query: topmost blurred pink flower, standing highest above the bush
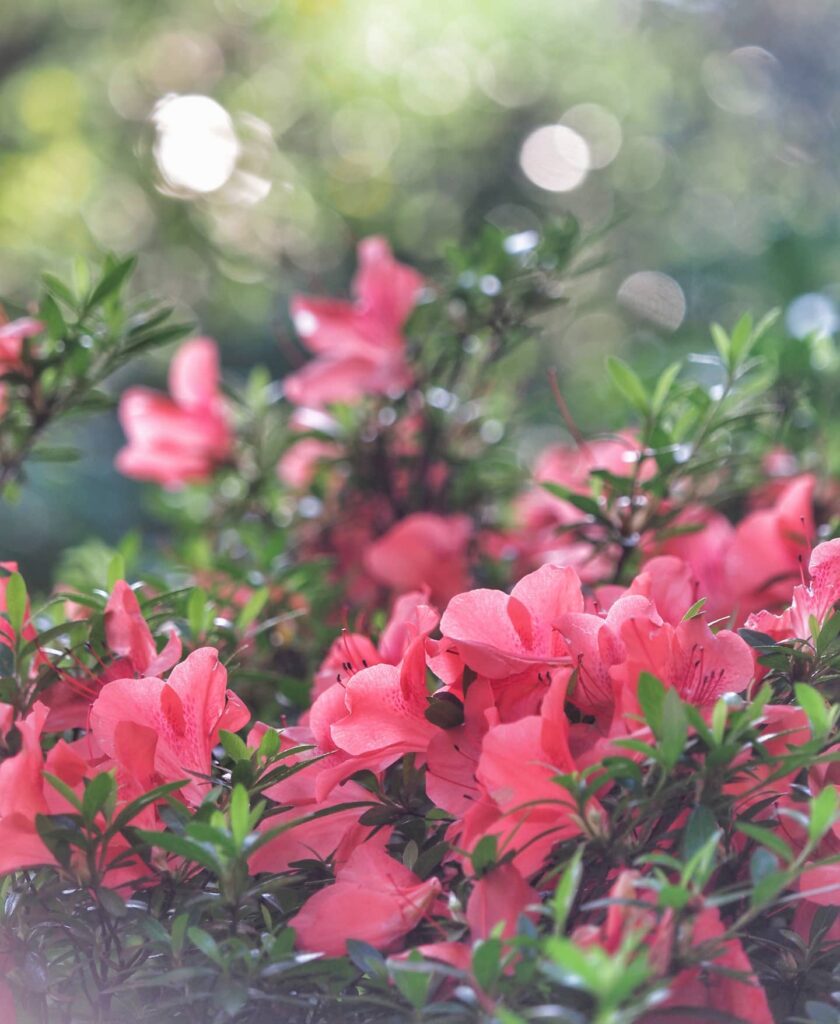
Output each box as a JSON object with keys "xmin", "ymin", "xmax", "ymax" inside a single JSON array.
[{"xmin": 284, "ymin": 238, "xmax": 423, "ymax": 408}]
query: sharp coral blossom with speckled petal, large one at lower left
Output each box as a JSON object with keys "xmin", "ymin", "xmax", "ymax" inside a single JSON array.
[{"xmin": 90, "ymin": 647, "xmax": 249, "ymax": 804}]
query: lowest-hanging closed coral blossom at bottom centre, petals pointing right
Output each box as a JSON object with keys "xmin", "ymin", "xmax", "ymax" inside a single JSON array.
[{"xmin": 290, "ymin": 839, "xmax": 440, "ymax": 956}]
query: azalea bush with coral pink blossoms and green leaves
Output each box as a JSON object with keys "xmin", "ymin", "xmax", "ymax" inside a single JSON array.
[{"xmin": 0, "ymin": 226, "xmax": 840, "ymax": 1024}]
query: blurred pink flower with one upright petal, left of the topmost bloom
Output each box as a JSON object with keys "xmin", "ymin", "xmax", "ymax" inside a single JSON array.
[{"xmin": 116, "ymin": 338, "xmax": 232, "ymax": 487}]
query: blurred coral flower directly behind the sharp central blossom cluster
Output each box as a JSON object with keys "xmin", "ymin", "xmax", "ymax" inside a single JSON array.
[{"xmin": 364, "ymin": 512, "xmax": 472, "ymax": 604}]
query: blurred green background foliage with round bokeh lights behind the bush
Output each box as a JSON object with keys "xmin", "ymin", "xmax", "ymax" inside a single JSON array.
[{"xmin": 0, "ymin": 0, "xmax": 840, "ymax": 581}]
